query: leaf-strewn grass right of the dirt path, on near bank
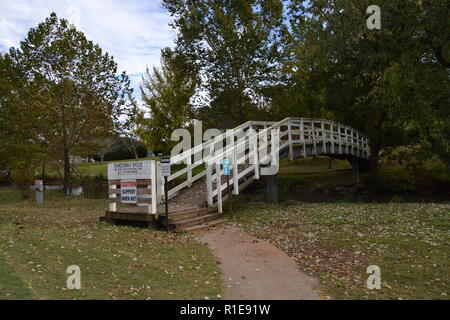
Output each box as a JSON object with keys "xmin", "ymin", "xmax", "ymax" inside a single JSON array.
[{"xmin": 230, "ymin": 202, "xmax": 450, "ymax": 299}]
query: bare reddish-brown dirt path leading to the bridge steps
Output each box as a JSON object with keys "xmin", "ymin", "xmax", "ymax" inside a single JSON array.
[{"xmin": 198, "ymin": 226, "xmax": 319, "ymax": 300}]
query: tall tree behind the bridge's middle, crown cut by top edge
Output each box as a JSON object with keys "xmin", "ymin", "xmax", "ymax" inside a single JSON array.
[{"xmin": 163, "ymin": 0, "xmax": 286, "ymax": 129}]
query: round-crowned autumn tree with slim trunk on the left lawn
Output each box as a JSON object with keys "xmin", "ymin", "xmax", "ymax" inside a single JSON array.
[{"xmin": 7, "ymin": 13, "xmax": 131, "ymax": 191}]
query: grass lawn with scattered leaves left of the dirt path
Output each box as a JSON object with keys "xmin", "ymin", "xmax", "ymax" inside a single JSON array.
[{"xmin": 0, "ymin": 191, "xmax": 224, "ymax": 299}]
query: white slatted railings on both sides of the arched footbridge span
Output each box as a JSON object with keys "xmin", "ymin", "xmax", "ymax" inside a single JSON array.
[{"xmin": 156, "ymin": 118, "xmax": 370, "ymax": 212}]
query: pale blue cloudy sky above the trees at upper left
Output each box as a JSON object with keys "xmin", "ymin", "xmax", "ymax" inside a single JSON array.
[{"xmin": 0, "ymin": 0, "xmax": 175, "ymax": 99}]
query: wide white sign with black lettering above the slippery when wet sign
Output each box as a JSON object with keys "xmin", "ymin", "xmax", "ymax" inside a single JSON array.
[{"xmin": 108, "ymin": 161, "xmax": 151, "ymax": 180}]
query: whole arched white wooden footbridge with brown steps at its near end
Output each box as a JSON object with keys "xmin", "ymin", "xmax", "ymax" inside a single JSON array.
[{"xmin": 104, "ymin": 118, "xmax": 370, "ymax": 231}]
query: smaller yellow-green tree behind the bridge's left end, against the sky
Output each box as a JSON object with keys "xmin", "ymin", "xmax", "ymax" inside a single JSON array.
[{"xmin": 136, "ymin": 49, "xmax": 197, "ymax": 154}]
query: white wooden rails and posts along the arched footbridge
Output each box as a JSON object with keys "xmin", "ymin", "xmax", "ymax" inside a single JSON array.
[{"xmin": 158, "ymin": 118, "xmax": 370, "ymax": 211}]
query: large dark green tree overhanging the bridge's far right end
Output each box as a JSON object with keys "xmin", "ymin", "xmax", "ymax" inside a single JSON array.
[{"xmin": 289, "ymin": 0, "xmax": 450, "ymax": 181}]
